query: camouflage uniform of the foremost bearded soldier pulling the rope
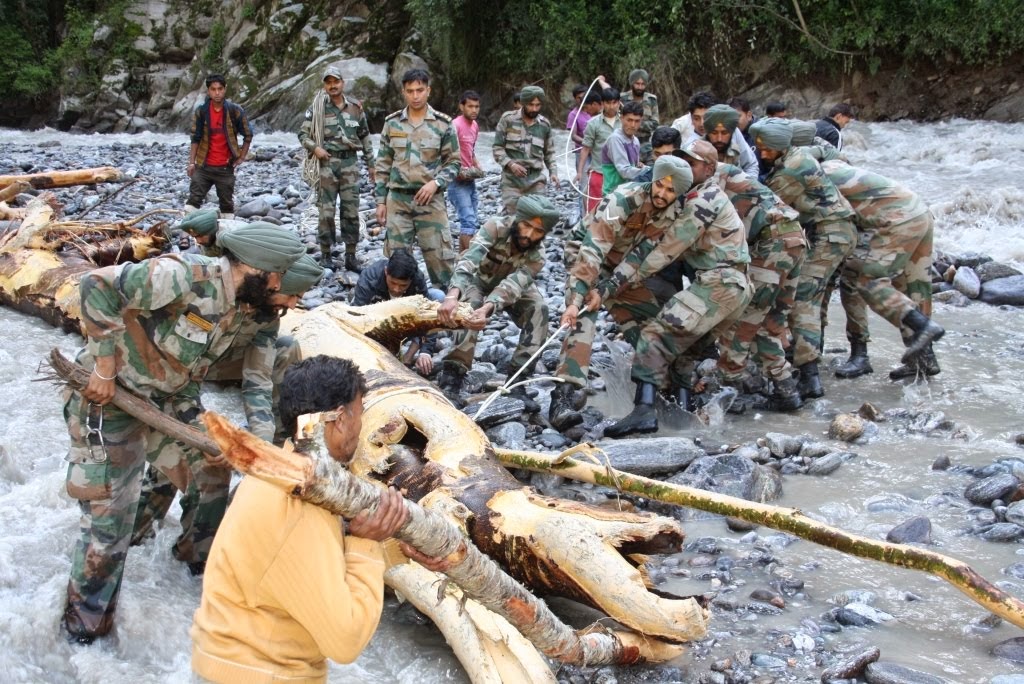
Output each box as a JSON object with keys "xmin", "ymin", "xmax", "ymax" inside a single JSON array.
[{"xmin": 555, "ymin": 183, "xmax": 682, "ymax": 387}]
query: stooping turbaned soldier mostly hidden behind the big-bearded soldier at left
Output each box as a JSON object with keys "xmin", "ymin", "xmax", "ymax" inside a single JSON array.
[{"xmin": 132, "ymin": 254, "xmax": 324, "ymax": 546}]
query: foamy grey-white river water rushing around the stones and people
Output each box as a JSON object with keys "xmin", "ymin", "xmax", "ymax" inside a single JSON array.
[{"xmin": 0, "ymin": 120, "xmax": 1024, "ymax": 684}]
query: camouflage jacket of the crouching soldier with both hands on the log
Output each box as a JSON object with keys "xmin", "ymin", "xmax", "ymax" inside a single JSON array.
[{"xmin": 451, "ymin": 216, "xmax": 544, "ymax": 311}]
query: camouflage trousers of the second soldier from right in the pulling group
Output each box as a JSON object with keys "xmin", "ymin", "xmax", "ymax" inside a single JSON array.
[{"xmin": 790, "ymin": 220, "xmax": 857, "ymax": 367}]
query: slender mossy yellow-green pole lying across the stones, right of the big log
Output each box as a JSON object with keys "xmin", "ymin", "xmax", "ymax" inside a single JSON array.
[{"xmin": 495, "ymin": 445, "xmax": 1024, "ymax": 628}]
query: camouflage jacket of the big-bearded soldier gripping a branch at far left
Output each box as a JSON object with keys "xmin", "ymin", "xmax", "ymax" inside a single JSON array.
[{"xmin": 80, "ymin": 254, "xmax": 246, "ymax": 398}]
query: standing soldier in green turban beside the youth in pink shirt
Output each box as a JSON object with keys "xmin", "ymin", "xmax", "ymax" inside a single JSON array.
[{"xmin": 492, "ymin": 86, "xmax": 558, "ymax": 216}]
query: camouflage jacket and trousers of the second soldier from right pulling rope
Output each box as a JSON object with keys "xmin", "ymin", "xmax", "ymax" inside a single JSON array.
[{"xmin": 766, "ymin": 146, "xmax": 857, "ymax": 366}]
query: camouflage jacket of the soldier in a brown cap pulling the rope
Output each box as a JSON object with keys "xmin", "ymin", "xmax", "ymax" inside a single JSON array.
[{"xmin": 611, "ymin": 176, "xmax": 751, "ymax": 287}]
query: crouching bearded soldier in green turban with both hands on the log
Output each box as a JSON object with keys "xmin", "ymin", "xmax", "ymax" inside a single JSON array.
[{"xmin": 437, "ymin": 195, "xmax": 560, "ymax": 403}]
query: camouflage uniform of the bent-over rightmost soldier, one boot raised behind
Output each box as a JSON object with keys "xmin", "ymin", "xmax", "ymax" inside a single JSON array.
[{"xmin": 821, "ymin": 161, "xmax": 933, "ymax": 341}]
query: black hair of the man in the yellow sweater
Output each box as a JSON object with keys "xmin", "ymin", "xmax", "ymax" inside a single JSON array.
[{"xmin": 279, "ymin": 354, "xmax": 367, "ymax": 435}]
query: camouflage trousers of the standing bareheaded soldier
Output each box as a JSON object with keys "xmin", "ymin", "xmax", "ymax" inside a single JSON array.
[{"xmin": 384, "ymin": 190, "xmax": 455, "ymax": 290}]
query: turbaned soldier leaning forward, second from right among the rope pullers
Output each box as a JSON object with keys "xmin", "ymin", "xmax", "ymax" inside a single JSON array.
[{"xmin": 751, "ymin": 119, "xmax": 857, "ymax": 399}]
